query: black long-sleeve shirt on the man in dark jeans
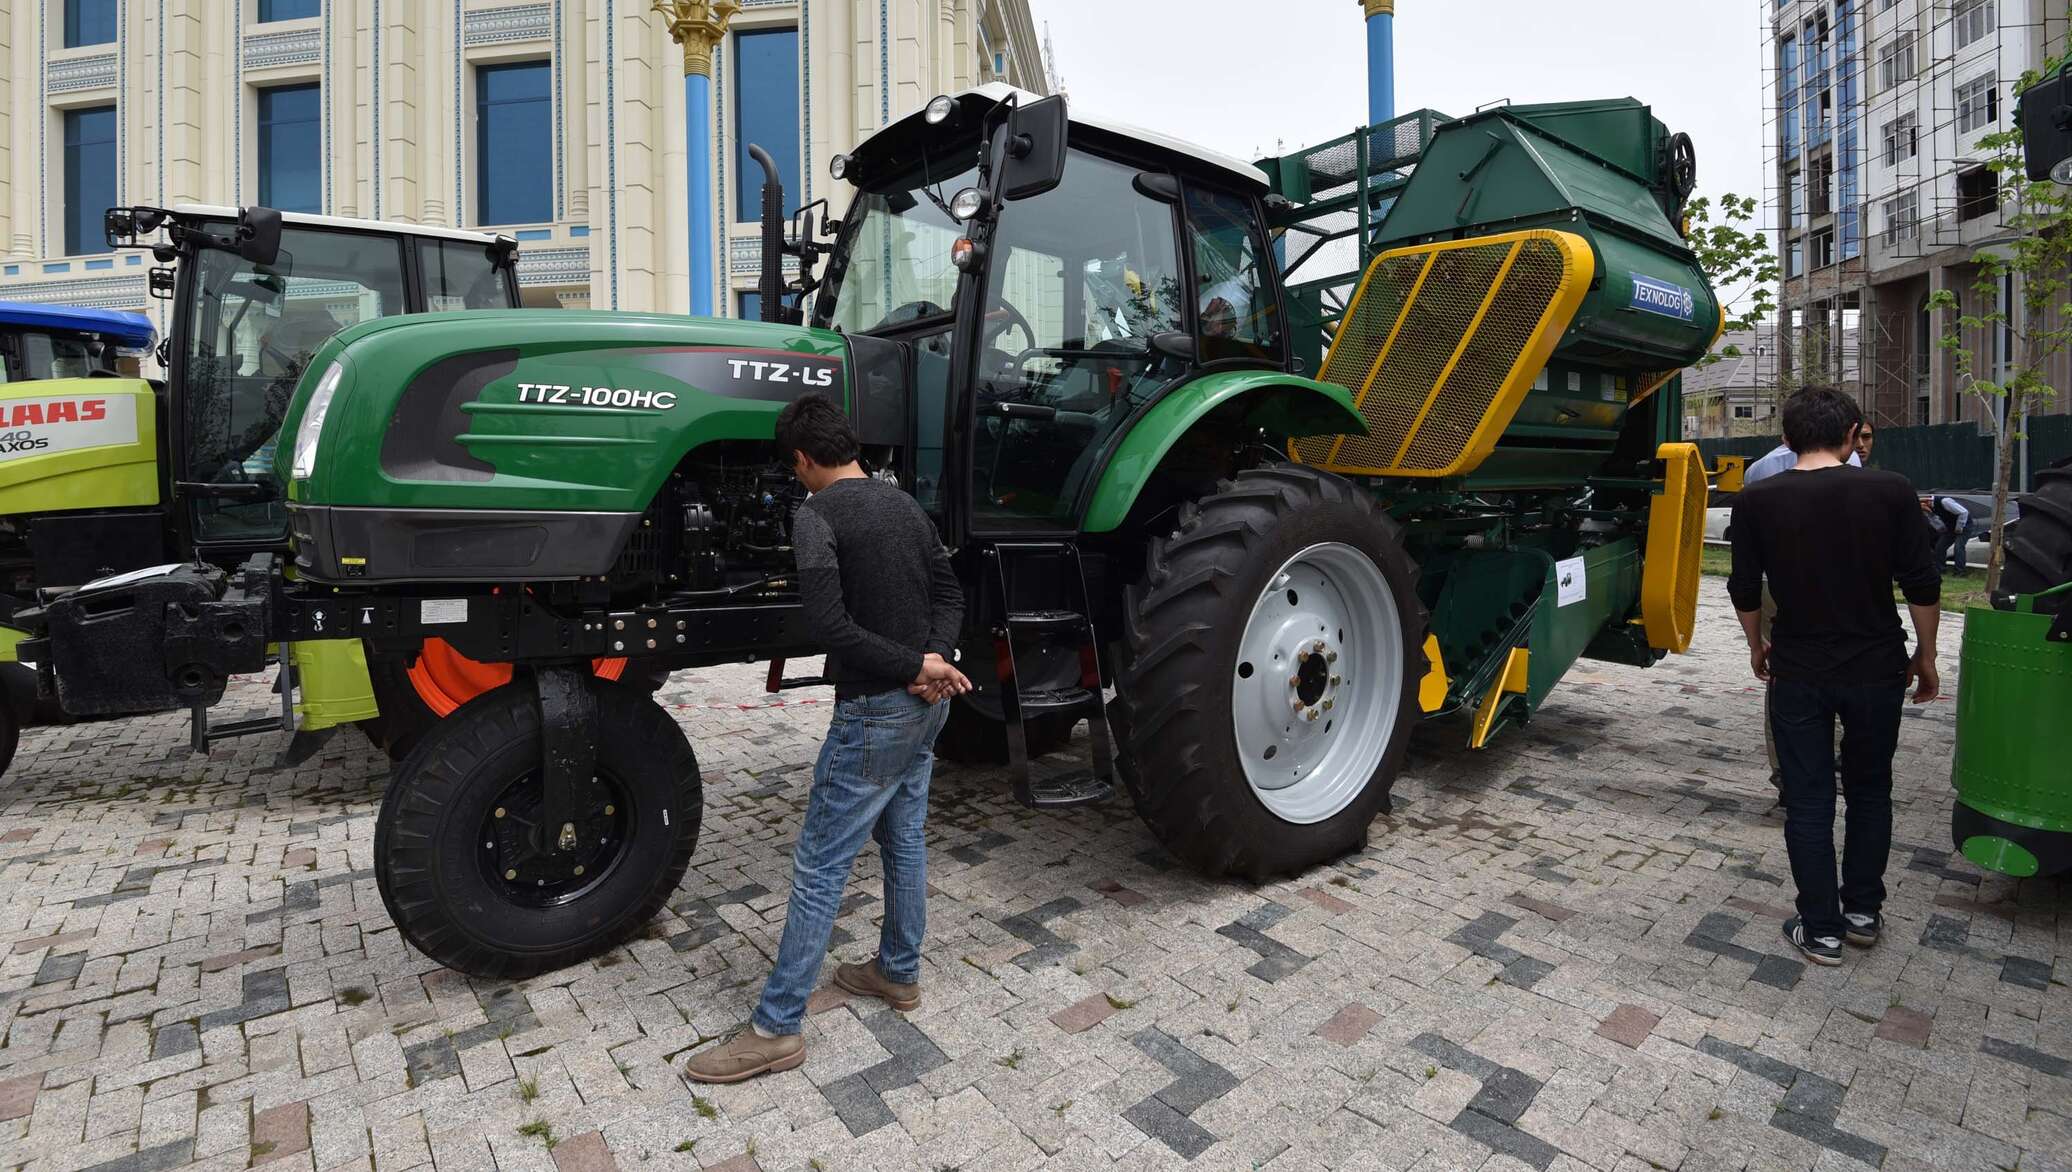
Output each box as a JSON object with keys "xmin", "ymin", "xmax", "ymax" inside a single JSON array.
[{"xmin": 1726, "ymin": 466, "xmax": 1941, "ymax": 683}]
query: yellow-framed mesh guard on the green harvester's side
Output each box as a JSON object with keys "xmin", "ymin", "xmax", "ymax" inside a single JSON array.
[{"xmin": 1297, "ymin": 228, "xmax": 1595, "ymax": 476}]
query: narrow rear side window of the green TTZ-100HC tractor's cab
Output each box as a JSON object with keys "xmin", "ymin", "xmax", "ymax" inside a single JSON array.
[{"xmin": 1185, "ymin": 184, "xmax": 1283, "ymax": 362}]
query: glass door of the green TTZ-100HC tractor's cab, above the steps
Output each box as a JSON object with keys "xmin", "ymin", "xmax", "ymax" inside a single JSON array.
[{"xmin": 966, "ymin": 149, "xmax": 1187, "ymax": 536}]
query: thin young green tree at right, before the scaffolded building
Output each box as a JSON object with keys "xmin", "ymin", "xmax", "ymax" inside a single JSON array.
[{"xmin": 1929, "ymin": 104, "xmax": 2072, "ymax": 592}]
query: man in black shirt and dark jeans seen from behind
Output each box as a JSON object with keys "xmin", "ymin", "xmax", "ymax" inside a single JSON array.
[{"xmin": 1726, "ymin": 387, "xmax": 1941, "ymax": 965}]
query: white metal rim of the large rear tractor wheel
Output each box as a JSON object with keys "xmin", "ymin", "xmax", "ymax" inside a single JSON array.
[{"xmin": 1229, "ymin": 543, "xmax": 1403, "ymax": 824}]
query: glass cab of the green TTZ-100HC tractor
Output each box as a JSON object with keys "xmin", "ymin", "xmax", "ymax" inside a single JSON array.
[{"xmin": 810, "ymin": 85, "xmax": 1289, "ymax": 545}]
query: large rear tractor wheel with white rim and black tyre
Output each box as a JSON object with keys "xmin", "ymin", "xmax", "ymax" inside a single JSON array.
[{"xmin": 1113, "ymin": 466, "xmax": 1426, "ymax": 882}]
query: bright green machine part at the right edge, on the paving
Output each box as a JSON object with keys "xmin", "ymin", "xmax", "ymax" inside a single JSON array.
[{"xmin": 1950, "ymin": 582, "xmax": 2072, "ymax": 878}]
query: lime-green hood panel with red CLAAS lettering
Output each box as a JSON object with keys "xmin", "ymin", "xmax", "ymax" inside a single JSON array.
[{"xmin": 0, "ymin": 379, "xmax": 157, "ymax": 516}]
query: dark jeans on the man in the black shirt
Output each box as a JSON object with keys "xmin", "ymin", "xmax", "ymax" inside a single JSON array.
[{"xmin": 1769, "ymin": 679, "xmax": 1906, "ymax": 936}]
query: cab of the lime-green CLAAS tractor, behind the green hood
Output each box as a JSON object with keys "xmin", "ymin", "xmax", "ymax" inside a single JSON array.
[{"xmin": 108, "ymin": 205, "xmax": 518, "ymax": 561}]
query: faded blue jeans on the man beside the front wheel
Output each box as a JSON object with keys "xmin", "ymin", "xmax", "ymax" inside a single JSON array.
[{"xmin": 754, "ymin": 692, "xmax": 949, "ymax": 1035}]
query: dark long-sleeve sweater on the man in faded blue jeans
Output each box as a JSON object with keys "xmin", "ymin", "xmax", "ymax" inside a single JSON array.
[{"xmin": 792, "ymin": 476, "xmax": 963, "ymax": 700}]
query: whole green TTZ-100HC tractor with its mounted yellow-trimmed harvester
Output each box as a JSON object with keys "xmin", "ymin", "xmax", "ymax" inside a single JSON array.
[{"xmin": 28, "ymin": 87, "xmax": 1720, "ymax": 975}]
